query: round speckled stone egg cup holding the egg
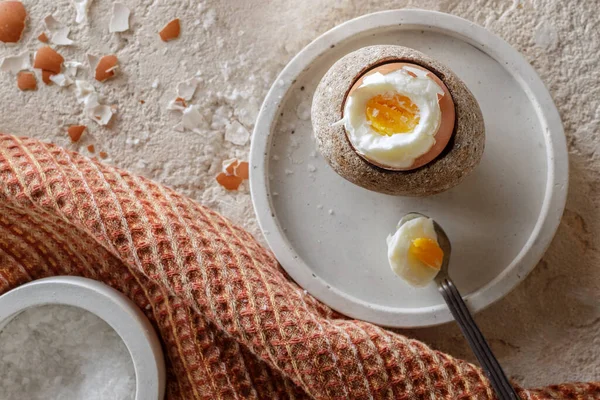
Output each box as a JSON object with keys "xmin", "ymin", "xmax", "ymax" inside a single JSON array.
[{"xmin": 311, "ymin": 45, "xmax": 485, "ymax": 197}]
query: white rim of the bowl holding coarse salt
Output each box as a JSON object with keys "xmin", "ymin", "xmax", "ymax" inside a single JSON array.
[{"xmin": 0, "ymin": 276, "xmax": 166, "ymax": 400}]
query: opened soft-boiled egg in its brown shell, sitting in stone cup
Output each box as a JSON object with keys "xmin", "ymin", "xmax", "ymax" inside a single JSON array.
[{"xmin": 343, "ymin": 62, "xmax": 455, "ymax": 171}]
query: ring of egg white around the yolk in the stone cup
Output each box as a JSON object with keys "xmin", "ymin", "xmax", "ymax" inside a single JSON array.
[{"xmin": 343, "ymin": 66, "xmax": 444, "ymax": 169}]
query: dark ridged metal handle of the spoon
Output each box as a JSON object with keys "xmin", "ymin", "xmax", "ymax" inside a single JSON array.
[{"xmin": 437, "ymin": 276, "xmax": 519, "ymax": 400}]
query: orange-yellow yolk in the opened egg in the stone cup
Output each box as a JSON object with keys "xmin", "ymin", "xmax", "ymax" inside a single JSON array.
[{"xmin": 365, "ymin": 93, "xmax": 419, "ymax": 136}]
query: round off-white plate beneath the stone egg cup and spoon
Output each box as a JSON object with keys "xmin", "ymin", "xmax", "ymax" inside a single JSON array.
[{"xmin": 250, "ymin": 10, "xmax": 568, "ymax": 327}]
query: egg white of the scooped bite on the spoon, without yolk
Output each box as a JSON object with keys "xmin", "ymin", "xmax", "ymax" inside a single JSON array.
[{"xmin": 387, "ymin": 217, "xmax": 439, "ymax": 287}]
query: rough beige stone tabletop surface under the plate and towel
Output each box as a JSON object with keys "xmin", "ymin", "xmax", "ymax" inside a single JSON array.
[{"xmin": 0, "ymin": 0, "xmax": 600, "ymax": 386}]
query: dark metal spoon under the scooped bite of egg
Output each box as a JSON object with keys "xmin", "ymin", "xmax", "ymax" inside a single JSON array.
[{"xmin": 399, "ymin": 213, "xmax": 519, "ymax": 400}]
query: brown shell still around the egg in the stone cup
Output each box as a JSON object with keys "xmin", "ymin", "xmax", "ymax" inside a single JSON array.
[{"xmin": 344, "ymin": 62, "xmax": 455, "ymax": 171}]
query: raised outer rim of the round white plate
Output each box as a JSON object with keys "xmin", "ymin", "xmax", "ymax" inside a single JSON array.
[{"xmin": 250, "ymin": 10, "xmax": 569, "ymax": 328}]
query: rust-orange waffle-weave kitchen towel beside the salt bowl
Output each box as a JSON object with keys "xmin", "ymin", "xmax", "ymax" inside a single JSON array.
[{"xmin": 0, "ymin": 135, "xmax": 600, "ymax": 400}]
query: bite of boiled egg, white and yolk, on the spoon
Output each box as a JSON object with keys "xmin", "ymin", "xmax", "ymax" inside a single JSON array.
[{"xmin": 387, "ymin": 217, "xmax": 444, "ymax": 287}]
